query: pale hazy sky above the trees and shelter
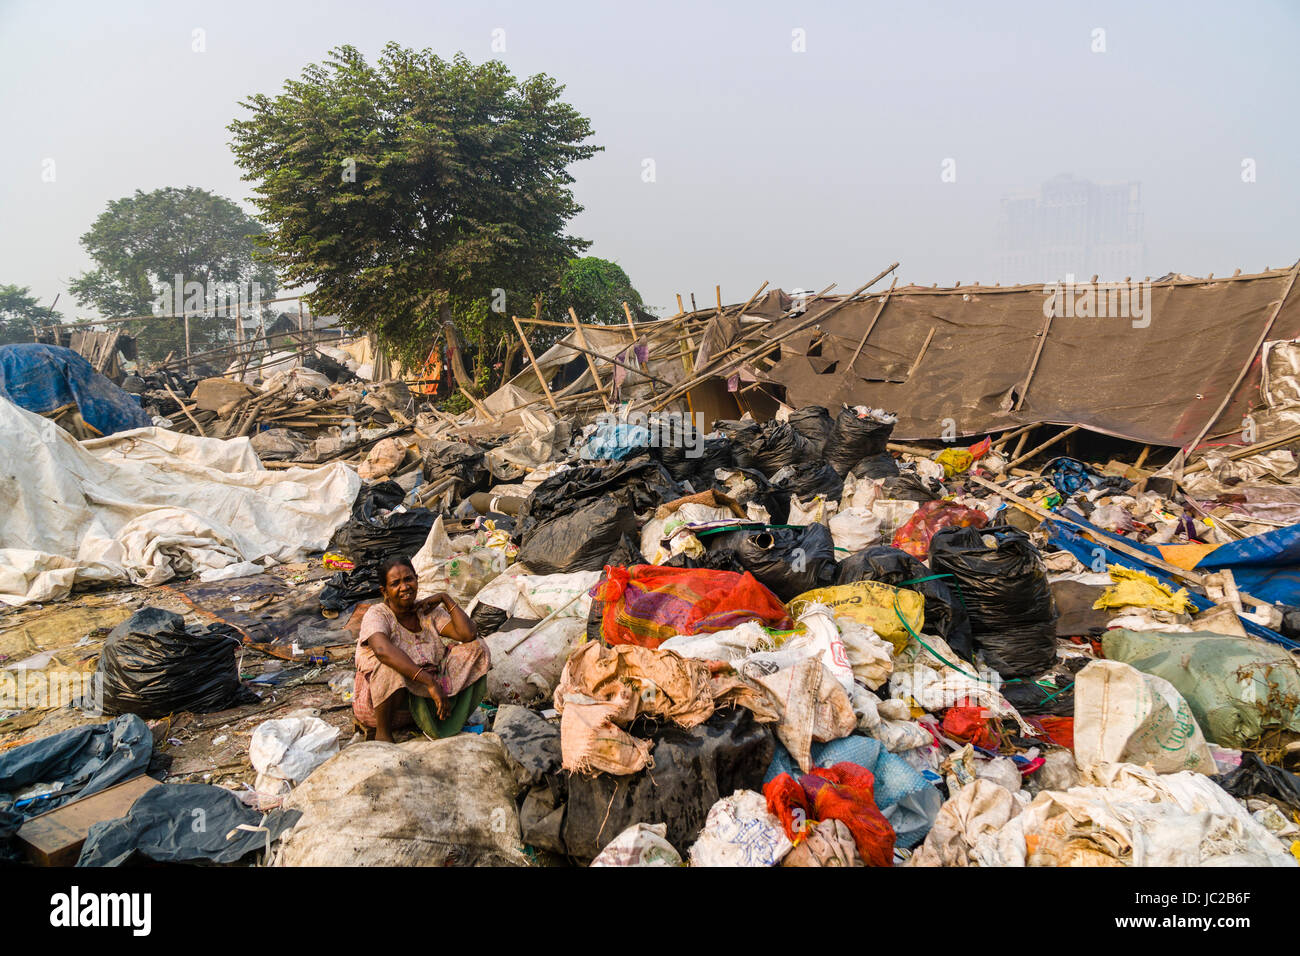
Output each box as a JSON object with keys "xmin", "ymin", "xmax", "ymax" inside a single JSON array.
[{"xmin": 0, "ymin": 0, "xmax": 1300, "ymax": 321}]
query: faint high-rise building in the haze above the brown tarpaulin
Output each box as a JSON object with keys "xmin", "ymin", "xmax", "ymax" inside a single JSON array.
[{"xmin": 996, "ymin": 174, "xmax": 1147, "ymax": 284}]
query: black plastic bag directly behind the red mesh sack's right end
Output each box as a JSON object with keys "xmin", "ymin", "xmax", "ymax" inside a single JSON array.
[{"xmin": 701, "ymin": 523, "xmax": 835, "ymax": 601}]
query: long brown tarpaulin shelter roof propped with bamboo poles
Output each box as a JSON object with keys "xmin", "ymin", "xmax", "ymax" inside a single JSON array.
[{"xmin": 762, "ymin": 269, "xmax": 1300, "ymax": 445}]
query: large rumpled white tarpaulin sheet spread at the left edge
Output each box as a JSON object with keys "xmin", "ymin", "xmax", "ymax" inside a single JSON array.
[{"xmin": 0, "ymin": 399, "xmax": 361, "ymax": 605}]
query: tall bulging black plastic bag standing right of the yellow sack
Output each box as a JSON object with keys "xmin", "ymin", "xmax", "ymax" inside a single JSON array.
[{"xmin": 930, "ymin": 525, "xmax": 1056, "ymax": 679}]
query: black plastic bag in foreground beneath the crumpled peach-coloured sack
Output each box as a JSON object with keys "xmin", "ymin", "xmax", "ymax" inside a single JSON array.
[{"xmin": 493, "ymin": 708, "xmax": 776, "ymax": 862}]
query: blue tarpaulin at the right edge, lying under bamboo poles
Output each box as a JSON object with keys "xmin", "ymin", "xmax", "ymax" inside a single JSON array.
[{"xmin": 1044, "ymin": 514, "xmax": 1300, "ymax": 650}]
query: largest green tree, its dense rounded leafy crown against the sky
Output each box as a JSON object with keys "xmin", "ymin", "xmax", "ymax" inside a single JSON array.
[{"xmin": 230, "ymin": 43, "xmax": 599, "ymax": 382}]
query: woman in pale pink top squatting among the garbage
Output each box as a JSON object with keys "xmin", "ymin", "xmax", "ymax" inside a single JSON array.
[{"xmin": 352, "ymin": 555, "xmax": 491, "ymax": 741}]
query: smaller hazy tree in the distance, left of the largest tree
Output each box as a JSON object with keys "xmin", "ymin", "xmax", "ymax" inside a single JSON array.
[{"xmin": 69, "ymin": 186, "xmax": 277, "ymax": 359}]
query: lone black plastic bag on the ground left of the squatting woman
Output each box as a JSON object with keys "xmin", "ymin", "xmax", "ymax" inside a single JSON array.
[{"xmin": 96, "ymin": 607, "xmax": 260, "ymax": 717}]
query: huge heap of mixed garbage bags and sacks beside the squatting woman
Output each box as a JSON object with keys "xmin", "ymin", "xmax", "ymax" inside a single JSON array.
[{"xmin": 0, "ymin": 392, "xmax": 1300, "ymax": 866}]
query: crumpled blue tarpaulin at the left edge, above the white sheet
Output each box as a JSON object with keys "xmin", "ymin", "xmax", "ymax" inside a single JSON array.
[{"xmin": 0, "ymin": 342, "xmax": 153, "ymax": 434}]
